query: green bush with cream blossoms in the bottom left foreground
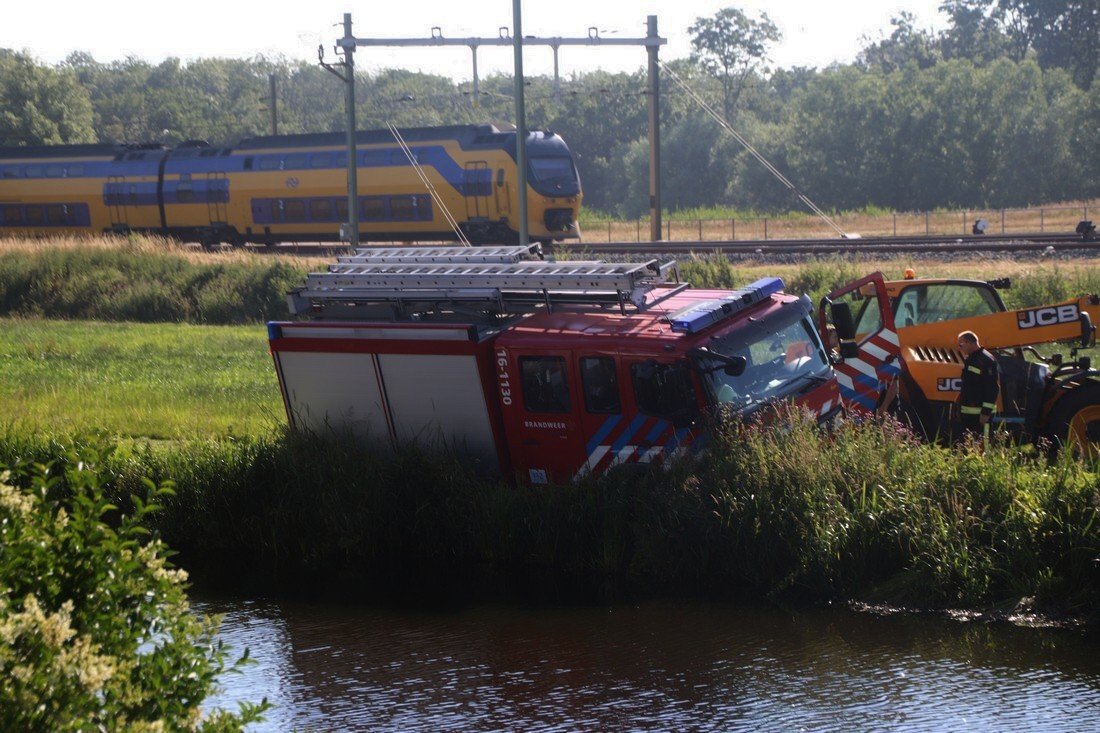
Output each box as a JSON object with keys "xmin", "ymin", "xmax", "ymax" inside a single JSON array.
[{"xmin": 0, "ymin": 451, "xmax": 267, "ymax": 732}]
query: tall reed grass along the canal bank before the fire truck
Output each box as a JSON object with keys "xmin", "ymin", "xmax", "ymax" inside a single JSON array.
[{"xmin": 0, "ymin": 417, "xmax": 1100, "ymax": 615}]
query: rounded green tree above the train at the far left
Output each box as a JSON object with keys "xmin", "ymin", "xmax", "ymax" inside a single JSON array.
[{"xmin": 0, "ymin": 48, "xmax": 96, "ymax": 145}]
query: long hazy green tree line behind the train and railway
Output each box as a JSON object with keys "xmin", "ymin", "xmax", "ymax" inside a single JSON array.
[{"xmin": 0, "ymin": 0, "xmax": 1100, "ymax": 217}]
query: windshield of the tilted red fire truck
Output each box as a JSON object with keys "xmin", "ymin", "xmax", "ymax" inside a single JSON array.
[{"xmin": 694, "ymin": 304, "xmax": 829, "ymax": 412}]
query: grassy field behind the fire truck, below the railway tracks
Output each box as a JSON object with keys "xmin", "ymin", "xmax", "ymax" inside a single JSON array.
[{"xmin": 0, "ymin": 234, "xmax": 1100, "ymax": 438}]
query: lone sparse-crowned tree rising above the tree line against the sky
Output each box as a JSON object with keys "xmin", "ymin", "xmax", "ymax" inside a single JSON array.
[{"xmin": 688, "ymin": 8, "xmax": 782, "ymax": 120}]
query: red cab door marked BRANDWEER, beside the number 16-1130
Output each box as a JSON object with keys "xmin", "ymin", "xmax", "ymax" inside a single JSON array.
[{"xmin": 496, "ymin": 349, "xmax": 585, "ymax": 484}]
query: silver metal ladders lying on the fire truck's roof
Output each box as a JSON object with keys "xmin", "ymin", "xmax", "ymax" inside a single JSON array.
[{"xmin": 287, "ymin": 245, "xmax": 688, "ymax": 319}]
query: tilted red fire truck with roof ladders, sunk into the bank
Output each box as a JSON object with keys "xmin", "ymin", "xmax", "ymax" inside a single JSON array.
[{"xmin": 268, "ymin": 245, "xmax": 839, "ymax": 484}]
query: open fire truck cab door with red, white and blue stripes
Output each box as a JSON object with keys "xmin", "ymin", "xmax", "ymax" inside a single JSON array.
[{"xmin": 818, "ymin": 272, "xmax": 901, "ymax": 413}]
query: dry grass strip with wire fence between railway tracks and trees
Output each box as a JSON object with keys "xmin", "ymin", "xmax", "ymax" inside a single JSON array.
[{"xmin": 580, "ymin": 199, "xmax": 1100, "ymax": 242}]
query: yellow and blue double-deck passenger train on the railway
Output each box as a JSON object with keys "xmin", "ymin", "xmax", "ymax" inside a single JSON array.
[{"xmin": 0, "ymin": 124, "xmax": 581, "ymax": 244}]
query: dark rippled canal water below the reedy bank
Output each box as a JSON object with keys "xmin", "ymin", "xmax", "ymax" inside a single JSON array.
[{"xmin": 197, "ymin": 600, "xmax": 1100, "ymax": 732}]
